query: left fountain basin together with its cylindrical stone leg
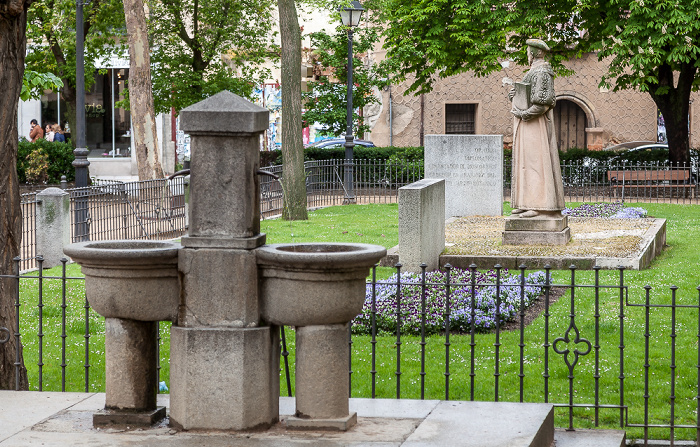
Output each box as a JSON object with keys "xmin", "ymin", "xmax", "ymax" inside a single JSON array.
[{"xmin": 64, "ymin": 241, "xmax": 180, "ymax": 426}]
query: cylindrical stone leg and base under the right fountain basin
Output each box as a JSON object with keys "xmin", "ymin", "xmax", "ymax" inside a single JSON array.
[{"xmin": 287, "ymin": 323, "xmax": 357, "ymax": 430}]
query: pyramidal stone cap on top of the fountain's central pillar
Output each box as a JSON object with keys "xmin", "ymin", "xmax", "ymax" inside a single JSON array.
[{"xmin": 180, "ymin": 90, "xmax": 270, "ymax": 134}]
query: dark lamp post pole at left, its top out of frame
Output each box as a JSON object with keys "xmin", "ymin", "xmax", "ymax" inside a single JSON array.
[{"xmin": 73, "ymin": 0, "xmax": 90, "ymax": 241}]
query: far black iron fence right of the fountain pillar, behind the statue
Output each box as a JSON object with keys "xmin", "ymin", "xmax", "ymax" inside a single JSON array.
[{"xmin": 260, "ymin": 159, "xmax": 700, "ymax": 218}]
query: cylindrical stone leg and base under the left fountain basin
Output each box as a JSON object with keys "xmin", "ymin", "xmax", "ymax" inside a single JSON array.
[{"xmin": 93, "ymin": 318, "xmax": 165, "ymax": 427}]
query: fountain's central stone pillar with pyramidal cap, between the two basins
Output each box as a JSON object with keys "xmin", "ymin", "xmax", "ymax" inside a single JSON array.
[{"xmin": 170, "ymin": 92, "xmax": 279, "ymax": 430}]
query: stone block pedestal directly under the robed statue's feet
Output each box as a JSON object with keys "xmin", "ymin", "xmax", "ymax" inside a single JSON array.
[{"xmin": 503, "ymin": 216, "xmax": 571, "ymax": 245}]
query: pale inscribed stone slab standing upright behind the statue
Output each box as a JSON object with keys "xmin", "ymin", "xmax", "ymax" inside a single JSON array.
[{"xmin": 425, "ymin": 135, "xmax": 503, "ymax": 218}]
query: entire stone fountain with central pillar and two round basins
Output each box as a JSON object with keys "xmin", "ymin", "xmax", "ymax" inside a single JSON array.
[{"xmin": 66, "ymin": 92, "xmax": 386, "ymax": 430}]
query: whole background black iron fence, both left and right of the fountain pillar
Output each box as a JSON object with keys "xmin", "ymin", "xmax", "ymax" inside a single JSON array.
[{"xmin": 21, "ymin": 160, "xmax": 700, "ymax": 270}]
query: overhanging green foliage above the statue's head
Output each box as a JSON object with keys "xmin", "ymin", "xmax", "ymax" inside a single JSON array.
[{"xmin": 365, "ymin": 0, "xmax": 578, "ymax": 93}]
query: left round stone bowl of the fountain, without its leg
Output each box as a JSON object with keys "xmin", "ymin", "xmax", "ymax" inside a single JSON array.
[{"xmin": 63, "ymin": 241, "xmax": 181, "ymax": 321}]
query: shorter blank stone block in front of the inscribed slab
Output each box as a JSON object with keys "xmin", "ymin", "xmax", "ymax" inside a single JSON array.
[{"xmin": 399, "ymin": 178, "xmax": 445, "ymax": 272}]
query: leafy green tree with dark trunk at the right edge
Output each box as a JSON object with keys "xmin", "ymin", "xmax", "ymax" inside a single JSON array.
[{"xmin": 579, "ymin": 0, "xmax": 700, "ymax": 162}]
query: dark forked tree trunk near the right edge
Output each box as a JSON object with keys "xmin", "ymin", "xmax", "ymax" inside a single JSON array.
[{"xmin": 650, "ymin": 64, "xmax": 697, "ymax": 165}]
